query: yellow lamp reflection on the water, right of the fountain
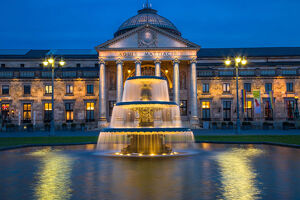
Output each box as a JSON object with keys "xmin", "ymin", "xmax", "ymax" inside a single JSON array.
[{"xmin": 216, "ymin": 148, "xmax": 262, "ymax": 200}]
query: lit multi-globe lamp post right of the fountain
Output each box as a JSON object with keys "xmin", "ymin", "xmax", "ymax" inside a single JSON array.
[{"xmin": 225, "ymin": 56, "xmax": 247, "ymax": 134}]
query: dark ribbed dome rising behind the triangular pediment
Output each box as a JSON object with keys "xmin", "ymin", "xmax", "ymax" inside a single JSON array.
[{"xmin": 114, "ymin": 6, "xmax": 181, "ymax": 37}]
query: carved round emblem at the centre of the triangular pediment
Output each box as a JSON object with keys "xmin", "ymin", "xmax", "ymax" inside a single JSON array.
[{"xmin": 138, "ymin": 29, "xmax": 157, "ymax": 47}]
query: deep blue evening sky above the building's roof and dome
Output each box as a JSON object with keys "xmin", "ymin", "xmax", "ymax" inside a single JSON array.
[{"xmin": 0, "ymin": 0, "xmax": 300, "ymax": 49}]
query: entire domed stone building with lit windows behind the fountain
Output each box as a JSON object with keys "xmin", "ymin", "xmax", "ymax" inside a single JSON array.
[{"xmin": 0, "ymin": 5, "xmax": 300, "ymax": 129}]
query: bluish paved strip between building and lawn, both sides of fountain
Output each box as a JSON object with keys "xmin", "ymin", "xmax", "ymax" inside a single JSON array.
[{"xmin": 0, "ymin": 129, "xmax": 300, "ymax": 138}]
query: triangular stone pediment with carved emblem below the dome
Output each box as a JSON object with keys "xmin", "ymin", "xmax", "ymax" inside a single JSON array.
[{"xmin": 96, "ymin": 25, "xmax": 200, "ymax": 50}]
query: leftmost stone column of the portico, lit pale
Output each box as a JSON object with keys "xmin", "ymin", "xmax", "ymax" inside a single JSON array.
[{"xmin": 98, "ymin": 59, "xmax": 107, "ymax": 128}]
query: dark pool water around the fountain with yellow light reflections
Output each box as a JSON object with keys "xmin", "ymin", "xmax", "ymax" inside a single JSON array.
[{"xmin": 0, "ymin": 143, "xmax": 300, "ymax": 200}]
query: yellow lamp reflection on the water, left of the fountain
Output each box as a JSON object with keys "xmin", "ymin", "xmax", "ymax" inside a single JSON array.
[{"xmin": 31, "ymin": 147, "xmax": 75, "ymax": 200}]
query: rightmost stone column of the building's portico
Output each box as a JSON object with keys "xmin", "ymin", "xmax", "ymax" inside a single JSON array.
[{"xmin": 190, "ymin": 59, "xmax": 198, "ymax": 126}]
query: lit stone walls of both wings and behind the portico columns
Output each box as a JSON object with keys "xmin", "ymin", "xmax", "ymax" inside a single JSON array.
[{"xmin": 0, "ymin": 53, "xmax": 300, "ymax": 129}]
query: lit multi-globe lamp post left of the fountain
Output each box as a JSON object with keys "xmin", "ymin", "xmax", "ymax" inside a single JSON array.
[{"xmin": 43, "ymin": 56, "xmax": 66, "ymax": 135}]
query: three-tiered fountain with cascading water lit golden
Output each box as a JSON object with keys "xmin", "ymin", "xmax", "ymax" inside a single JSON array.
[{"xmin": 97, "ymin": 76, "xmax": 194, "ymax": 157}]
